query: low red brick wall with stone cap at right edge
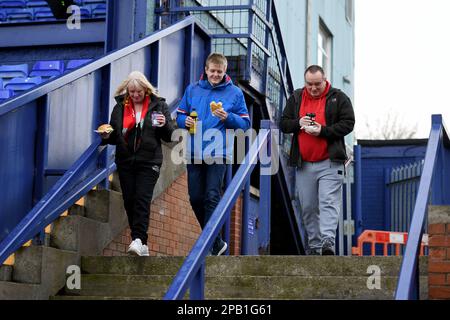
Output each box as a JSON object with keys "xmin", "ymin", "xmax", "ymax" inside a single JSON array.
[{"xmin": 428, "ymin": 206, "xmax": 450, "ymax": 299}]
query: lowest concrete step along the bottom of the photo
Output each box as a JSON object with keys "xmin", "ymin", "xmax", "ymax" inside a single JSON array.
[{"xmin": 59, "ymin": 274, "xmax": 427, "ymax": 300}]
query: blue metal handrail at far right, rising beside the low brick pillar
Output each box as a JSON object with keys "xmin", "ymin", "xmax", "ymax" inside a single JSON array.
[{"xmin": 395, "ymin": 115, "xmax": 450, "ymax": 300}]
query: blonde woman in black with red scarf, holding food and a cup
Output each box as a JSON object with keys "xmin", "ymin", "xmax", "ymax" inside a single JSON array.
[{"xmin": 100, "ymin": 71, "xmax": 174, "ymax": 256}]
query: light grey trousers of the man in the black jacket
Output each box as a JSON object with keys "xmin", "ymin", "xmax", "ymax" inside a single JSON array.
[{"xmin": 296, "ymin": 160, "xmax": 344, "ymax": 253}]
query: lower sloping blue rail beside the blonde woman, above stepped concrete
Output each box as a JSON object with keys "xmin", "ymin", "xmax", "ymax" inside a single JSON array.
[{"xmin": 0, "ymin": 137, "xmax": 115, "ymax": 262}]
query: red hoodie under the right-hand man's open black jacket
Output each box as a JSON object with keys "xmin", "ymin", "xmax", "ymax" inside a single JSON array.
[{"xmin": 298, "ymin": 81, "xmax": 331, "ymax": 162}]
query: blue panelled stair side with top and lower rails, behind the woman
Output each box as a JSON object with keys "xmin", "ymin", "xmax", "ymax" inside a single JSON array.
[{"xmin": 0, "ymin": 17, "xmax": 210, "ymax": 262}]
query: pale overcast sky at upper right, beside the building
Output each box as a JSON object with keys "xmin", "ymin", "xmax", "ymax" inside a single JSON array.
[{"xmin": 355, "ymin": 0, "xmax": 450, "ymax": 138}]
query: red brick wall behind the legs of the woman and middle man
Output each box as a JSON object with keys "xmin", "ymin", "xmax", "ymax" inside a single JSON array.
[{"xmin": 103, "ymin": 173, "xmax": 242, "ymax": 256}]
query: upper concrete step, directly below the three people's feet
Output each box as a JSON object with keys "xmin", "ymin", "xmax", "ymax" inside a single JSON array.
[{"xmin": 81, "ymin": 256, "xmax": 427, "ymax": 277}]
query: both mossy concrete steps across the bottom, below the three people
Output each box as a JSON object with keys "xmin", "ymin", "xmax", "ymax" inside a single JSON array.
[{"xmin": 51, "ymin": 256, "xmax": 428, "ymax": 300}]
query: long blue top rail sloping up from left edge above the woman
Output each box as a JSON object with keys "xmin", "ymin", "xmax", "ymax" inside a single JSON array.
[{"xmin": 0, "ymin": 16, "xmax": 209, "ymax": 116}]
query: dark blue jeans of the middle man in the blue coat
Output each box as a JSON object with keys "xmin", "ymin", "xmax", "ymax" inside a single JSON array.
[{"xmin": 187, "ymin": 163, "xmax": 227, "ymax": 248}]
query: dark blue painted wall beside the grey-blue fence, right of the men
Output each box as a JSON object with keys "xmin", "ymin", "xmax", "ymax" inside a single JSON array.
[{"xmin": 358, "ymin": 140, "xmax": 426, "ymax": 230}]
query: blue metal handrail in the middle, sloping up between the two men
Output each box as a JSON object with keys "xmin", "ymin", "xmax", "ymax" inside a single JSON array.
[{"xmin": 164, "ymin": 121, "xmax": 271, "ymax": 300}]
